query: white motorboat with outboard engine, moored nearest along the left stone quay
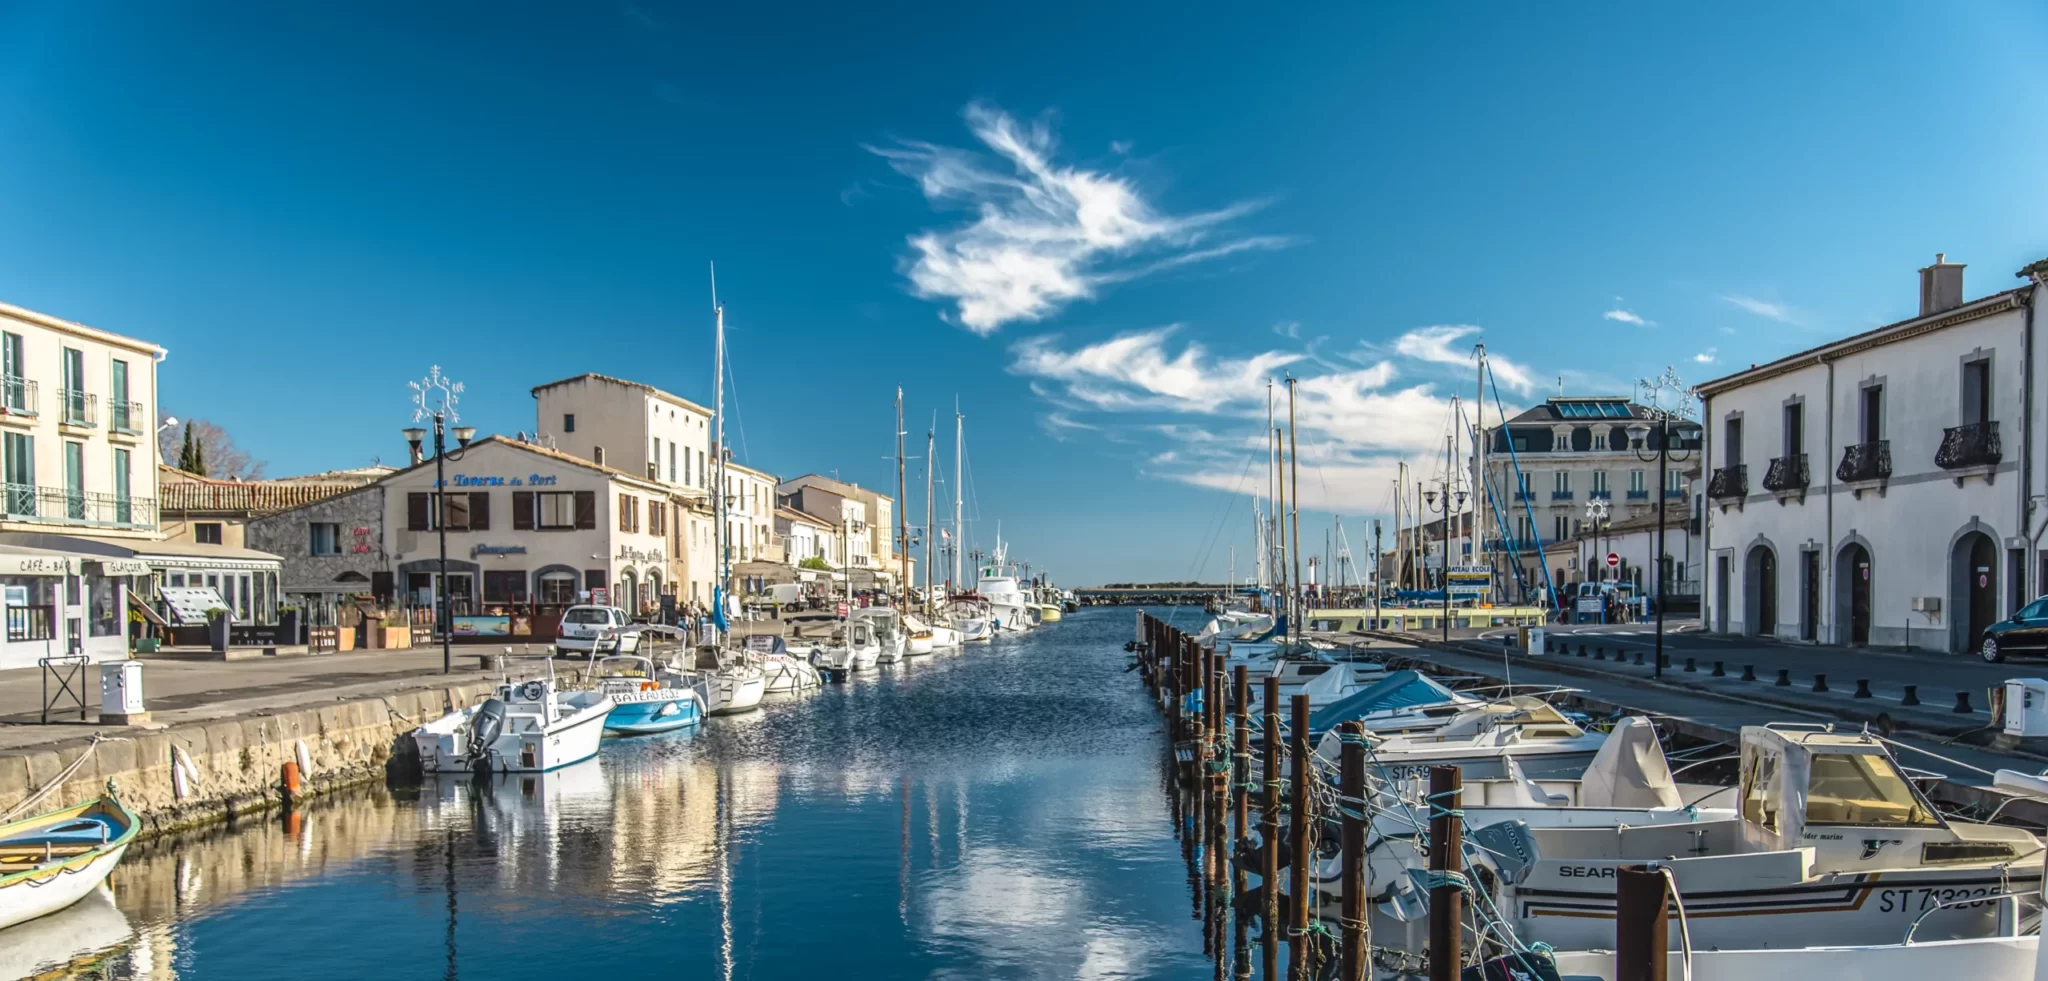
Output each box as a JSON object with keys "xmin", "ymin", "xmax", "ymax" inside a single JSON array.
[{"xmin": 412, "ymin": 662, "xmax": 612, "ymax": 774}]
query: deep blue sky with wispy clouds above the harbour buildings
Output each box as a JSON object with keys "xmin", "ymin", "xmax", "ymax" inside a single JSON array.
[{"xmin": 0, "ymin": 0, "xmax": 2048, "ymax": 584}]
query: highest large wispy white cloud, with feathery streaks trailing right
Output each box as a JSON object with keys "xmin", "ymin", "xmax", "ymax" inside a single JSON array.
[{"xmin": 868, "ymin": 102, "xmax": 1290, "ymax": 336}]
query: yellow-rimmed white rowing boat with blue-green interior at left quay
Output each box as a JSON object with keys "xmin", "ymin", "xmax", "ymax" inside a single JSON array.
[{"xmin": 0, "ymin": 786, "xmax": 135, "ymax": 930}]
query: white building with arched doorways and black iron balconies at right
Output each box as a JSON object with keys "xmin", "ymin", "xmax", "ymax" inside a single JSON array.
[{"xmin": 1700, "ymin": 256, "xmax": 2048, "ymax": 651}]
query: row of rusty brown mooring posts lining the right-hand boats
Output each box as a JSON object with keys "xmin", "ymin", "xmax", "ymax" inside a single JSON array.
[{"xmin": 1128, "ymin": 612, "xmax": 1669, "ymax": 981}]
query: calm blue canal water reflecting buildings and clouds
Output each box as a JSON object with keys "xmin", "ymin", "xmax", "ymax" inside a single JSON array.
[{"xmin": 16, "ymin": 608, "xmax": 1210, "ymax": 981}]
